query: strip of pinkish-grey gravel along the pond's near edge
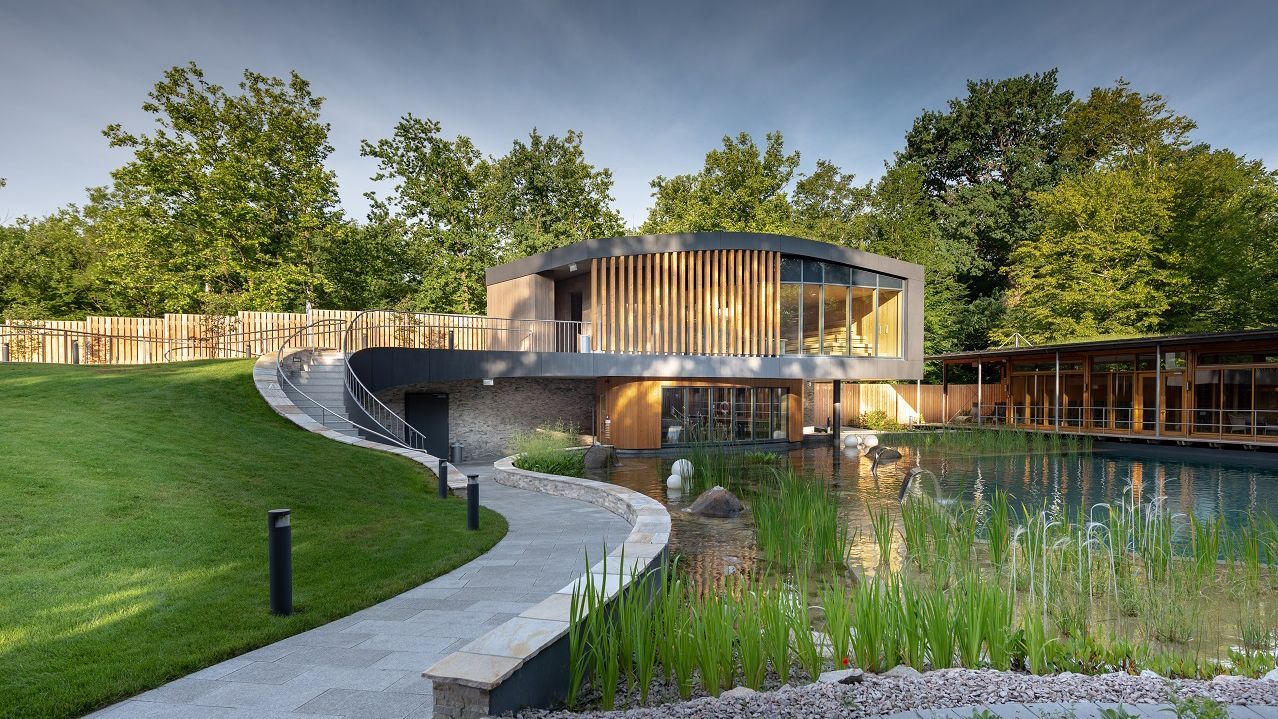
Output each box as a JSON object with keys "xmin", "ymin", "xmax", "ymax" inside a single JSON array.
[{"xmin": 519, "ymin": 669, "xmax": 1278, "ymax": 719}]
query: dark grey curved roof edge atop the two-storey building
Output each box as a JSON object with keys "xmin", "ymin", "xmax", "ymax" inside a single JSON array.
[{"xmin": 486, "ymin": 232, "xmax": 923, "ymax": 285}]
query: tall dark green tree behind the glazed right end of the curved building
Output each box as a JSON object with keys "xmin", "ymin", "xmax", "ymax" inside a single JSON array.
[{"xmin": 896, "ymin": 69, "xmax": 1072, "ymax": 292}]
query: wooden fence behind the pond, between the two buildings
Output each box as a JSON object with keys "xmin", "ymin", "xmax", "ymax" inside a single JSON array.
[{"xmin": 812, "ymin": 382, "xmax": 1003, "ymax": 424}]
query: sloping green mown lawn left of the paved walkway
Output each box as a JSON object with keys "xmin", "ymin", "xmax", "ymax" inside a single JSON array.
[{"xmin": 0, "ymin": 360, "xmax": 506, "ymax": 718}]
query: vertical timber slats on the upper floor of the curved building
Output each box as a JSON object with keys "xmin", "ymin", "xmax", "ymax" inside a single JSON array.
[{"xmin": 590, "ymin": 250, "xmax": 781, "ymax": 355}]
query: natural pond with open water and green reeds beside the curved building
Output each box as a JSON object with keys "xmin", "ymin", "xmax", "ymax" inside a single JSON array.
[{"xmin": 571, "ymin": 430, "xmax": 1278, "ymax": 708}]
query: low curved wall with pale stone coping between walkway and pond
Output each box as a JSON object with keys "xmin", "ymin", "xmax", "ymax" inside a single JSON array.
[{"xmin": 423, "ymin": 457, "xmax": 670, "ymax": 719}]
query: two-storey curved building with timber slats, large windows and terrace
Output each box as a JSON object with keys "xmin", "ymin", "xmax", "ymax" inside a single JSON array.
[{"xmin": 349, "ymin": 232, "xmax": 923, "ymax": 456}]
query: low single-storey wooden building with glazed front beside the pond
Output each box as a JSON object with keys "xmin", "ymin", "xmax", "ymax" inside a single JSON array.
[{"xmin": 930, "ymin": 329, "xmax": 1278, "ymax": 446}]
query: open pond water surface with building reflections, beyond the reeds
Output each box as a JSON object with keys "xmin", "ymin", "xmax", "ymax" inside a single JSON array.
[{"xmin": 597, "ymin": 447, "xmax": 1278, "ymax": 584}]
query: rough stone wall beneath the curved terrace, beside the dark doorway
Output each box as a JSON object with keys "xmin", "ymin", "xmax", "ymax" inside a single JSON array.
[{"xmin": 377, "ymin": 378, "xmax": 594, "ymax": 462}]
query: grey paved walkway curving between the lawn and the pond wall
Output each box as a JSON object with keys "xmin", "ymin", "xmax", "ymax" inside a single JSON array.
[{"xmin": 91, "ymin": 465, "xmax": 630, "ymax": 719}]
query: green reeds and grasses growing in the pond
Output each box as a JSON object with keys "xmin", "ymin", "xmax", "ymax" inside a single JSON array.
[{"xmin": 571, "ymin": 432, "xmax": 1278, "ymax": 709}]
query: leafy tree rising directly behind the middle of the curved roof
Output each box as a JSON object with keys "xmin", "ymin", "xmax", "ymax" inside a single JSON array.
[{"xmin": 642, "ymin": 133, "xmax": 799, "ymax": 234}]
